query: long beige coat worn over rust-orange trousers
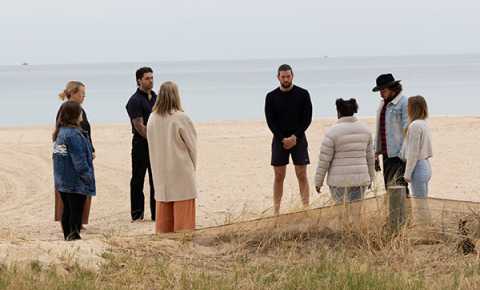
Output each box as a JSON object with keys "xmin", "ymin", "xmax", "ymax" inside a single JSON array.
[{"xmin": 147, "ymin": 112, "xmax": 197, "ymax": 202}]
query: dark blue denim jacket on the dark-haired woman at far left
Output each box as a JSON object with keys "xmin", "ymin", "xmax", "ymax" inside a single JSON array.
[{"xmin": 53, "ymin": 127, "xmax": 96, "ymax": 196}]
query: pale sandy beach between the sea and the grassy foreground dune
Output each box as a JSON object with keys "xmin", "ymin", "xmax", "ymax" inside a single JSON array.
[{"xmin": 0, "ymin": 117, "xmax": 480, "ymax": 267}]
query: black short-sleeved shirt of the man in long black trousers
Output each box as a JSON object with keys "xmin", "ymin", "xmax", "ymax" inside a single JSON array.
[{"xmin": 126, "ymin": 89, "xmax": 157, "ymax": 138}]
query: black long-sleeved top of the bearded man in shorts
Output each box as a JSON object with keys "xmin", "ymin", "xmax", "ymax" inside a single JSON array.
[{"xmin": 265, "ymin": 86, "xmax": 312, "ymax": 140}]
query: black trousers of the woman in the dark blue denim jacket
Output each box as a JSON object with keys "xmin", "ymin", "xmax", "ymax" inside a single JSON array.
[{"xmin": 60, "ymin": 192, "xmax": 87, "ymax": 241}]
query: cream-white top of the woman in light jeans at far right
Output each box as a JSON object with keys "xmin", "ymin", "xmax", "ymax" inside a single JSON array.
[{"xmin": 401, "ymin": 120, "xmax": 433, "ymax": 179}]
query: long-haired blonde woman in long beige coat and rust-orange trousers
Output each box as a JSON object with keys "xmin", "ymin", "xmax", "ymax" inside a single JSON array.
[{"xmin": 147, "ymin": 82, "xmax": 197, "ymax": 233}]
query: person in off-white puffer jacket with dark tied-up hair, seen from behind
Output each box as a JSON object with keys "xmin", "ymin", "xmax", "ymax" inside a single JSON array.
[{"xmin": 315, "ymin": 99, "xmax": 375, "ymax": 203}]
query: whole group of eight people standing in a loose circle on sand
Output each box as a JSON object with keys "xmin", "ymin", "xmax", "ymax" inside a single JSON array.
[{"xmin": 53, "ymin": 64, "xmax": 432, "ymax": 240}]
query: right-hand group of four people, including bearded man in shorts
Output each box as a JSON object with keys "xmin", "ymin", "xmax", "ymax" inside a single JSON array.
[{"xmin": 265, "ymin": 65, "xmax": 433, "ymax": 214}]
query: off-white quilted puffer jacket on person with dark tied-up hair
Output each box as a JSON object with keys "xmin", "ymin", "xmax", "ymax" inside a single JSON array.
[{"xmin": 315, "ymin": 117, "xmax": 375, "ymax": 187}]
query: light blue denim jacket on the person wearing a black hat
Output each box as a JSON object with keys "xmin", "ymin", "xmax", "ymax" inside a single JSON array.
[{"xmin": 375, "ymin": 94, "xmax": 408, "ymax": 158}]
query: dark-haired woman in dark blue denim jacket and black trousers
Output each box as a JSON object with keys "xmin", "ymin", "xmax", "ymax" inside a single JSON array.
[{"xmin": 53, "ymin": 101, "xmax": 96, "ymax": 241}]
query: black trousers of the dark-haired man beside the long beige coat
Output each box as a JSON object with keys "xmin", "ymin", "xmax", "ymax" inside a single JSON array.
[{"xmin": 130, "ymin": 136, "xmax": 155, "ymax": 220}]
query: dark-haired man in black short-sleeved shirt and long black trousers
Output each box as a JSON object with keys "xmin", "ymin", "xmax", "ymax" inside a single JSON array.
[{"xmin": 127, "ymin": 67, "xmax": 157, "ymax": 221}]
